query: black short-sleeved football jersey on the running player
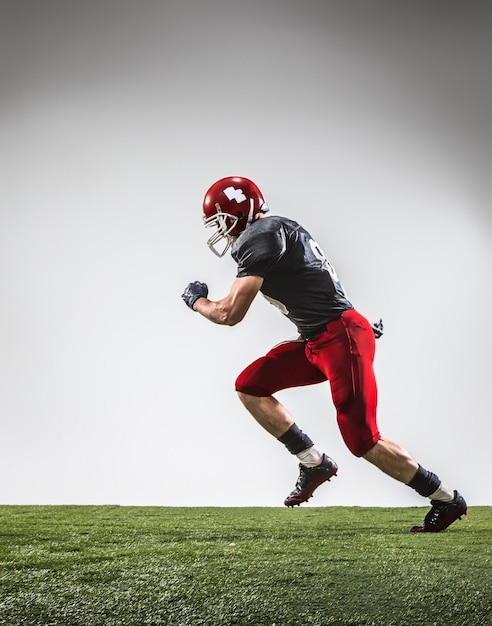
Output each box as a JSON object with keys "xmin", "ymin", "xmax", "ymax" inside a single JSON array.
[{"xmin": 231, "ymin": 215, "xmax": 353, "ymax": 337}]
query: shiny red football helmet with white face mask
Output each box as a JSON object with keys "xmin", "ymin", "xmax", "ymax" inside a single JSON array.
[{"xmin": 203, "ymin": 176, "xmax": 268, "ymax": 257}]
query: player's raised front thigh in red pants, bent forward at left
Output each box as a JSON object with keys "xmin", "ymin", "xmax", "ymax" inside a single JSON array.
[{"xmin": 236, "ymin": 341, "xmax": 326, "ymax": 397}]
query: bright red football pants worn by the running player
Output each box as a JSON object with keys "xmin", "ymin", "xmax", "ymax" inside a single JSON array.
[{"xmin": 236, "ymin": 309, "xmax": 381, "ymax": 456}]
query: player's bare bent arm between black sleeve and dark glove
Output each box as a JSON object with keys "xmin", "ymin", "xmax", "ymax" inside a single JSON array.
[{"xmin": 184, "ymin": 276, "xmax": 263, "ymax": 326}]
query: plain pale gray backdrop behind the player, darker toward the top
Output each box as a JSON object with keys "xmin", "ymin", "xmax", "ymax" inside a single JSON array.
[{"xmin": 0, "ymin": 0, "xmax": 492, "ymax": 506}]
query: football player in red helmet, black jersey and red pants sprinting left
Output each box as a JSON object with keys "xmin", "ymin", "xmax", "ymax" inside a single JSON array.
[{"xmin": 182, "ymin": 176, "xmax": 467, "ymax": 532}]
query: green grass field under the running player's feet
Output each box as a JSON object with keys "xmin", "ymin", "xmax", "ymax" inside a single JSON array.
[{"xmin": 0, "ymin": 506, "xmax": 492, "ymax": 626}]
